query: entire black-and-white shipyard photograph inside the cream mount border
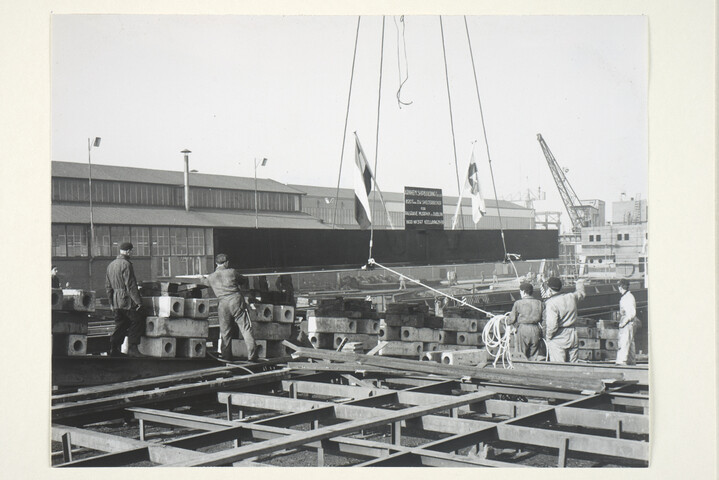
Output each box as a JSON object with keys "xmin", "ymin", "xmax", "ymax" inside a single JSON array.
[{"xmin": 48, "ymin": 15, "xmax": 652, "ymax": 469}]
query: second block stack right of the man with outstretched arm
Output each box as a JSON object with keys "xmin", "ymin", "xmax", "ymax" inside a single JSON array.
[{"xmin": 307, "ymin": 297, "xmax": 381, "ymax": 351}]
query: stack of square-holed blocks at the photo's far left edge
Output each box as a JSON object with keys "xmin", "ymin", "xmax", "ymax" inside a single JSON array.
[{"xmin": 51, "ymin": 288, "xmax": 95, "ymax": 357}]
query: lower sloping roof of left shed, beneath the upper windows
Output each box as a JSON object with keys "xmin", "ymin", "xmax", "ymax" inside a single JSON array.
[{"xmin": 51, "ymin": 204, "xmax": 331, "ymax": 229}]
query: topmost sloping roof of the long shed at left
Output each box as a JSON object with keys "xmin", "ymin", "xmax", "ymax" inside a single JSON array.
[{"xmin": 52, "ymin": 161, "xmax": 304, "ymax": 195}]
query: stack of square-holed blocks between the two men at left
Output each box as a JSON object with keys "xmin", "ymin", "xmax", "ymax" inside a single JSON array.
[{"xmin": 138, "ymin": 296, "xmax": 210, "ymax": 358}]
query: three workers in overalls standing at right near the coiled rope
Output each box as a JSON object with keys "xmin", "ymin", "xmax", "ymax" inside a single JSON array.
[{"xmin": 507, "ymin": 277, "xmax": 641, "ymax": 365}]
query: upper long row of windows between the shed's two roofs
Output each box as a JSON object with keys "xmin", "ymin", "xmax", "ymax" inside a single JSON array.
[{"xmin": 52, "ymin": 177, "xmax": 301, "ymax": 212}]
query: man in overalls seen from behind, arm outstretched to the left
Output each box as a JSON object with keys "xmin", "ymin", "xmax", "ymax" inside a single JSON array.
[{"xmin": 206, "ymin": 253, "xmax": 258, "ymax": 361}]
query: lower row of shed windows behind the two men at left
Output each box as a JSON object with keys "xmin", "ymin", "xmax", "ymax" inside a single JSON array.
[{"xmin": 52, "ymin": 224, "xmax": 213, "ymax": 257}]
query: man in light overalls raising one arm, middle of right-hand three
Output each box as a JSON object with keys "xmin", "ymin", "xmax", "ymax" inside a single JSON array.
[{"xmin": 544, "ymin": 277, "xmax": 585, "ymax": 362}]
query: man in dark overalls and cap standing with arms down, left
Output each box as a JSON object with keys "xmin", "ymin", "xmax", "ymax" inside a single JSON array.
[{"xmin": 105, "ymin": 242, "xmax": 145, "ymax": 357}]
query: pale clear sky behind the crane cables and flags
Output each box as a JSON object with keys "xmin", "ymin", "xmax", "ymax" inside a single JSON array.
[{"xmin": 51, "ymin": 15, "xmax": 648, "ymax": 229}]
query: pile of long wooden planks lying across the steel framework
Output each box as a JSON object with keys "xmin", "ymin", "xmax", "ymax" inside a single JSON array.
[{"xmin": 286, "ymin": 342, "xmax": 624, "ymax": 393}]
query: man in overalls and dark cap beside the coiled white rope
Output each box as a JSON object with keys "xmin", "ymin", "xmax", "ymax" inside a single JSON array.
[{"xmin": 507, "ymin": 282, "xmax": 544, "ymax": 361}]
